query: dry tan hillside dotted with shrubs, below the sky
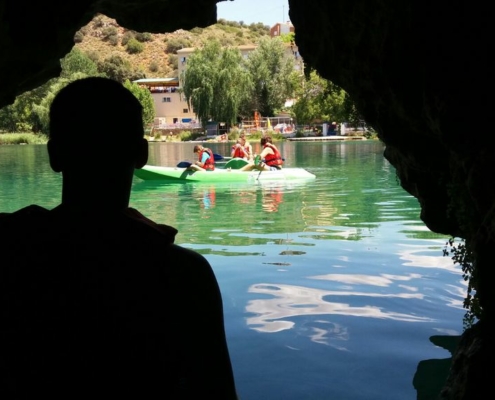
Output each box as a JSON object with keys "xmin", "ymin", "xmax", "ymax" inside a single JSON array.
[{"xmin": 74, "ymin": 14, "xmax": 269, "ymax": 78}]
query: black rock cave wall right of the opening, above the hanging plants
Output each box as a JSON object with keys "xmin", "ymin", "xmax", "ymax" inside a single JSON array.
[{"xmin": 289, "ymin": 0, "xmax": 495, "ymax": 315}]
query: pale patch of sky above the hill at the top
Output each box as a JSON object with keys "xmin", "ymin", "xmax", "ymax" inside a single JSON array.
[{"xmin": 217, "ymin": 0, "xmax": 289, "ymax": 27}]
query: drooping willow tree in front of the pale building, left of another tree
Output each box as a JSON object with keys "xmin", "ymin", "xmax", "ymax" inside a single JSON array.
[{"xmin": 180, "ymin": 41, "xmax": 252, "ymax": 126}]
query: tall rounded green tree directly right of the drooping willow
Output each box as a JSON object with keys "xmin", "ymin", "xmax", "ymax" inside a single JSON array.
[{"xmin": 243, "ymin": 37, "xmax": 298, "ymax": 116}]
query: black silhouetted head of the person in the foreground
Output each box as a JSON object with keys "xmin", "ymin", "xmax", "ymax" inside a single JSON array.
[{"xmin": 48, "ymin": 77, "xmax": 148, "ymax": 172}]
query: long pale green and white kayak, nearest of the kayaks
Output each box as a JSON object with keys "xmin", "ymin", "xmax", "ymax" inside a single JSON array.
[{"xmin": 134, "ymin": 165, "xmax": 316, "ymax": 183}]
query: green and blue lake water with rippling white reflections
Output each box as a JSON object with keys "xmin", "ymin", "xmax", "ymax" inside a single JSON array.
[{"xmin": 0, "ymin": 141, "xmax": 466, "ymax": 400}]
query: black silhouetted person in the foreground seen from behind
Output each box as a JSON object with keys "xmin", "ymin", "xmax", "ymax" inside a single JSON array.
[{"xmin": 0, "ymin": 78, "xmax": 236, "ymax": 399}]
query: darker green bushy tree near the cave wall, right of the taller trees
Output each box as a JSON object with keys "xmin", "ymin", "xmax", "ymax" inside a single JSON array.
[{"xmin": 292, "ymin": 71, "xmax": 349, "ymax": 124}]
